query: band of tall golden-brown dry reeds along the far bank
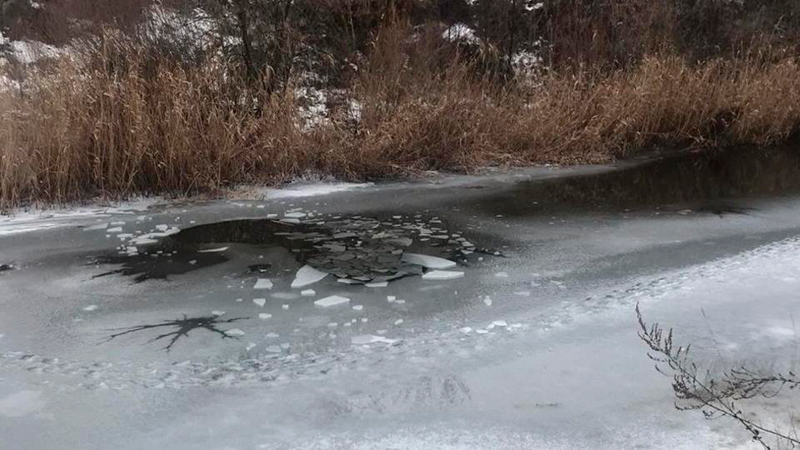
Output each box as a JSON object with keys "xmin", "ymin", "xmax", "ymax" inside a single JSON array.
[{"xmin": 0, "ymin": 30, "xmax": 800, "ymax": 207}]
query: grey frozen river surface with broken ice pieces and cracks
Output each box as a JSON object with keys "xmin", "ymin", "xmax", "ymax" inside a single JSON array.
[{"xmin": 0, "ymin": 148, "xmax": 800, "ymax": 449}]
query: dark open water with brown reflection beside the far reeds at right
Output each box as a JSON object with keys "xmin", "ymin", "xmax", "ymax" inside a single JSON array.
[{"xmin": 478, "ymin": 148, "xmax": 800, "ymax": 216}]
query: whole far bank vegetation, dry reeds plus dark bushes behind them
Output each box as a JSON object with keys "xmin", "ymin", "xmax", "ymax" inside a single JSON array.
[{"xmin": 0, "ymin": 0, "xmax": 800, "ymax": 209}]
